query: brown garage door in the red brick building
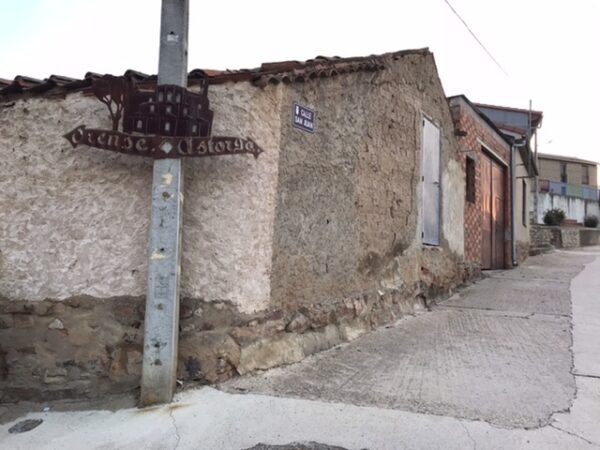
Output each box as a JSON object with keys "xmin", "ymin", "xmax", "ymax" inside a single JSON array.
[{"xmin": 481, "ymin": 155, "xmax": 505, "ymax": 269}]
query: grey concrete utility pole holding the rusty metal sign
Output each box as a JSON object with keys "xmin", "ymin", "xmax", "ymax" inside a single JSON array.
[{"xmin": 141, "ymin": 0, "xmax": 189, "ymax": 406}]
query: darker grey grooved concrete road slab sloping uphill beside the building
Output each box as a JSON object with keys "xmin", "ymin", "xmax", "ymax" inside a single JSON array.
[{"xmin": 223, "ymin": 253, "xmax": 593, "ymax": 428}]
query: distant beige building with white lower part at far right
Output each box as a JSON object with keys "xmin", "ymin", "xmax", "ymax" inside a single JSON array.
[{"xmin": 537, "ymin": 153, "xmax": 600, "ymax": 223}]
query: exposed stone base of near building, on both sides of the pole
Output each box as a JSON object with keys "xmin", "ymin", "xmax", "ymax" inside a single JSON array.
[{"xmin": 0, "ymin": 266, "xmax": 480, "ymax": 403}]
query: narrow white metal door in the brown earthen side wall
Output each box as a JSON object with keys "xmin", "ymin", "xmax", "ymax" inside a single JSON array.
[{"xmin": 421, "ymin": 118, "xmax": 440, "ymax": 245}]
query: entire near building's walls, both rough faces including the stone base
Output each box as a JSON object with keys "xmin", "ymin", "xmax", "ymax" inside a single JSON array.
[{"xmin": 0, "ymin": 50, "xmax": 468, "ymax": 401}]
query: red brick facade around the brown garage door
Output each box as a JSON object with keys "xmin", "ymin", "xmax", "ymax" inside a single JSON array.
[{"xmin": 449, "ymin": 96, "xmax": 512, "ymax": 268}]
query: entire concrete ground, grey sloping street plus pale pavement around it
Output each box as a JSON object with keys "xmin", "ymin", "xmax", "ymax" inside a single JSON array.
[{"xmin": 0, "ymin": 247, "xmax": 600, "ymax": 450}]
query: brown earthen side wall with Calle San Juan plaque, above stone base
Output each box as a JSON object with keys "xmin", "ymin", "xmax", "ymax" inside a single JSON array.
[{"xmin": 272, "ymin": 55, "xmax": 464, "ymax": 307}]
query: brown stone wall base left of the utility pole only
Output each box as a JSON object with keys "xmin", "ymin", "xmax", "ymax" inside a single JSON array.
[{"xmin": 0, "ymin": 297, "xmax": 144, "ymax": 402}]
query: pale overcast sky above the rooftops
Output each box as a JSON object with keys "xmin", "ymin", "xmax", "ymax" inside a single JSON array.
[{"xmin": 0, "ymin": 0, "xmax": 600, "ymax": 161}]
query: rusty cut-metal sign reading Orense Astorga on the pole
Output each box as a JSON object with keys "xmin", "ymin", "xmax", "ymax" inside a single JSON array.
[{"xmin": 64, "ymin": 75, "xmax": 263, "ymax": 158}]
